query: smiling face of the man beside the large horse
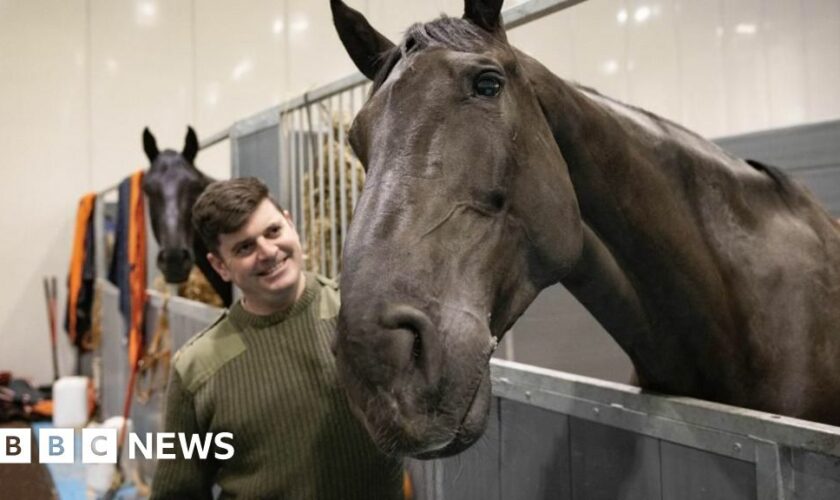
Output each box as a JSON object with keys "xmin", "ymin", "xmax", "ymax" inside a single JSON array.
[{"xmin": 208, "ymin": 199, "xmax": 304, "ymax": 312}]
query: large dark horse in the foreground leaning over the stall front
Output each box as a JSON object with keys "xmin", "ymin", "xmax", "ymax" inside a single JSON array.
[{"xmin": 331, "ymin": 0, "xmax": 840, "ymax": 458}]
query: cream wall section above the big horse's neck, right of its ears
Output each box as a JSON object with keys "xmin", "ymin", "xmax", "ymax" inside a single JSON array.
[{"xmin": 509, "ymin": 0, "xmax": 840, "ymax": 137}]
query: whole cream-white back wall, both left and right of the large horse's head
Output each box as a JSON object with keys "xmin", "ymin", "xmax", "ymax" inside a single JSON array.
[{"xmin": 0, "ymin": 0, "xmax": 840, "ymax": 382}]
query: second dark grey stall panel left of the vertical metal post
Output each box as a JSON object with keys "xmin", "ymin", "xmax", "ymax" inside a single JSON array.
[{"xmin": 570, "ymin": 418, "xmax": 662, "ymax": 500}]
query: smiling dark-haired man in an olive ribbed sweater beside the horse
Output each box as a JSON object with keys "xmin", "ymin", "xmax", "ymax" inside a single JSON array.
[{"xmin": 152, "ymin": 178, "xmax": 402, "ymax": 499}]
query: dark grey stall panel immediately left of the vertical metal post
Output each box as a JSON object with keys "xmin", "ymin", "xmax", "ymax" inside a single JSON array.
[{"xmin": 660, "ymin": 441, "xmax": 756, "ymax": 500}]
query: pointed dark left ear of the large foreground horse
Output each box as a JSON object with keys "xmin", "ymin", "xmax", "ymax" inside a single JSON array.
[{"xmin": 330, "ymin": 0, "xmax": 394, "ymax": 80}]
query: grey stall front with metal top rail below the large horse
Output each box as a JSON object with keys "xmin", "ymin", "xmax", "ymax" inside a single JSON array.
[{"xmin": 419, "ymin": 360, "xmax": 840, "ymax": 500}]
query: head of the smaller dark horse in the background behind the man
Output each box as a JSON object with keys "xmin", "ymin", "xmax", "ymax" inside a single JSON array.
[{"xmin": 143, "ymin": 127, "xmax": 209, "ymax": 283}]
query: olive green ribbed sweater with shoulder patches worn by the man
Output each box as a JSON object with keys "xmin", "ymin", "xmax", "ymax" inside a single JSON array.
[{"xmin": 152, "ymin": 273, "xmax": 402, "ymax": 499}]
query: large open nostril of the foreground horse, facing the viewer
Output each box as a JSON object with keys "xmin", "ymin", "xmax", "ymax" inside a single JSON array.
[{"xmin": 380, "ymin": 304, "xmax": 442, "ymax": 384}]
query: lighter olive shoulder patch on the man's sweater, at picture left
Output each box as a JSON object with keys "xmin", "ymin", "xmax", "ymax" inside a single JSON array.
[{"xmin": 173, "ymin": 312, "xmax": 246, "ymax": 393}]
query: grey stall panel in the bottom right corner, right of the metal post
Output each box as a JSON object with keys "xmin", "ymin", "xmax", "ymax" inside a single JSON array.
[{"xmin": 791, "ymin": 450, "xmax": 840, "ymax": 500}]
